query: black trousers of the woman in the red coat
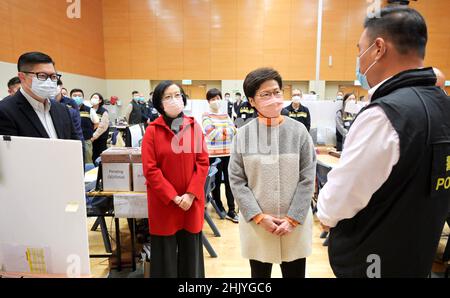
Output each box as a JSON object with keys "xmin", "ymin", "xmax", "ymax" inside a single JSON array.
[{"xmin": 150, "ymin": 230, "xmax": 205, "ymax": 278}]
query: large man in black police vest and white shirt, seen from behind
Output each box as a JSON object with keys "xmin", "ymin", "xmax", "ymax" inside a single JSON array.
[{"xmin": 317, "ymin": 6, "xmax": 450, "ymax": 277}]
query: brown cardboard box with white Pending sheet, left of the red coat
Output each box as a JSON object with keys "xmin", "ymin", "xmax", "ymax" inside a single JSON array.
[{"xmin": 101, "ymin": 148, "xmax": 132, "ymax": 191}]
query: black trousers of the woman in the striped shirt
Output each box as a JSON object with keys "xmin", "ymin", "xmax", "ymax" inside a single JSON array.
[{"xmin": 209, "ymin": 156, "xmax": 236, "ymax": 212}]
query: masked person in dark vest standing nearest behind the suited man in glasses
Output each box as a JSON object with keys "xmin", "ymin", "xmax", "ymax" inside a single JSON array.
[{"xmin": 70, "ymin": 89, "xmax": 100, "ymax": 164}]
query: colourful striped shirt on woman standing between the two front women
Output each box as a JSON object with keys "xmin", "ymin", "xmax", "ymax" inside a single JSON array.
[{"xmin": 202, "ymin": 113, "xmax": 236, "ymax": 157}]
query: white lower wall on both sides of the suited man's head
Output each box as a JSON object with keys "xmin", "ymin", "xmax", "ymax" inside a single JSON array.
[{"xmin": 0, "ymin": 62, "xmax": 107, "ymax": 99}]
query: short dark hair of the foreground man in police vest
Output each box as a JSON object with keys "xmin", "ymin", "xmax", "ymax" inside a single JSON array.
[{"xmin": 364, "ymin": 5, "xmax": 428, "ymax": 59}]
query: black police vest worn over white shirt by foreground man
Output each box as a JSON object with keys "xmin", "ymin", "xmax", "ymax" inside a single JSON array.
[{"xmin": 329, "ymin": 68, "xmax": 450, "ymax": 277}]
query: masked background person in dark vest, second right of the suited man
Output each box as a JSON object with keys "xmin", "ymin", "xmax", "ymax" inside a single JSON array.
[{"xmin": 91, "ymin": 93, "xmax": 109, "ymax": 162}]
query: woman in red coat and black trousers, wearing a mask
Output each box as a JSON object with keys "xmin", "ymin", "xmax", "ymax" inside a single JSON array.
[{"xmin": 142, "ymin": 81, "xmax": 209, "ymax": 278}]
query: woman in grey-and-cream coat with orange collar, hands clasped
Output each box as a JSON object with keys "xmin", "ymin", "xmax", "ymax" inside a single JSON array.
[{"xmin": 228, "ymin": 68, "xmax": 316, "ymax": 278}]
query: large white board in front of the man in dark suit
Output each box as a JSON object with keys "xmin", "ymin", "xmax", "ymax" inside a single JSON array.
[{"xmin": 0, "ymin": 136, "xmax": 90, "ymax": 277}]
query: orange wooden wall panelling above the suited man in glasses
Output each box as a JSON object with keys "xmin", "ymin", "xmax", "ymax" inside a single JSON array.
[{"xmin": 0, "ymin": 0, "xmax": 105, "ymax": 78}]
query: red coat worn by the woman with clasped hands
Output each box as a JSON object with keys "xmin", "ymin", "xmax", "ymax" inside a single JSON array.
[{"xmin": 142, "ymin": 117, "xmax": 209, "ymax": 236}]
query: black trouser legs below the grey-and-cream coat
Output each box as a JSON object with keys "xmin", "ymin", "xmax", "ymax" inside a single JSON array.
[{"xmin": 250, "ymin": 259, "xmax": 306, "ymax": 278}]
